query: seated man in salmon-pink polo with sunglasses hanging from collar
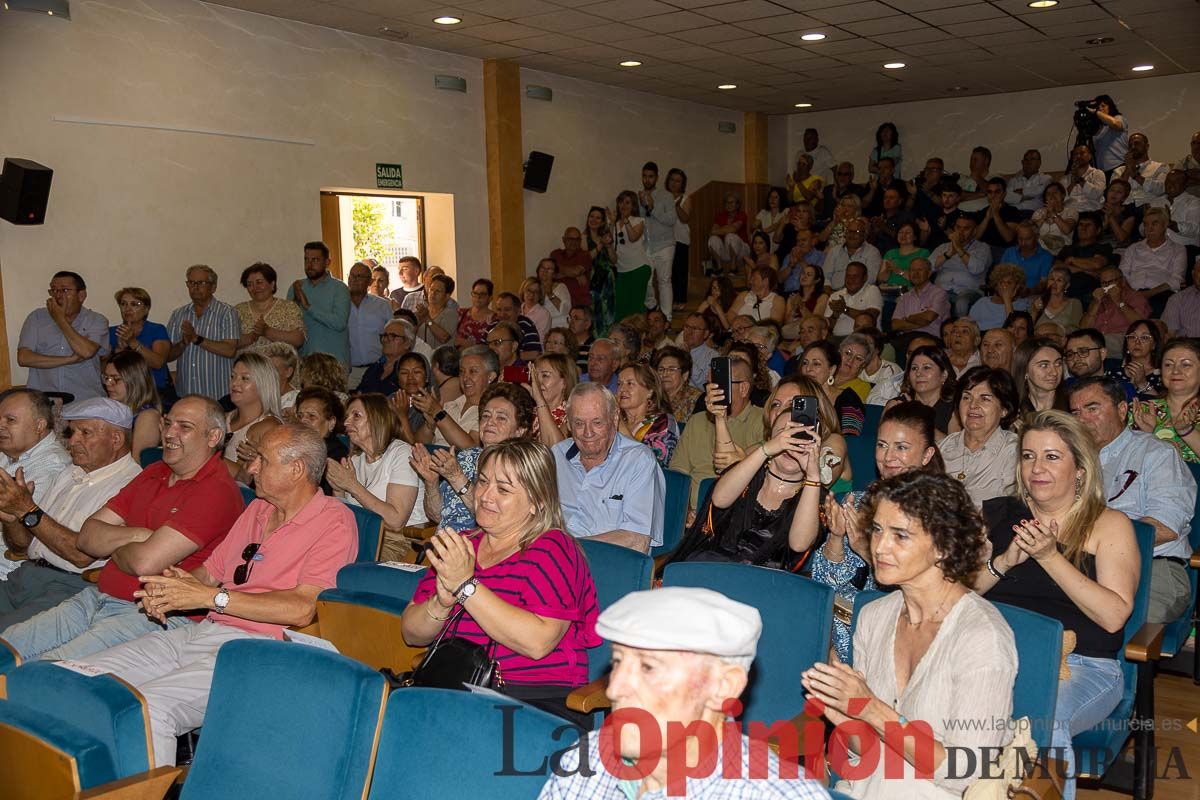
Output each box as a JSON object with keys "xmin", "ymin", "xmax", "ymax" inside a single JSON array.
[{"xmin": 78, "ymin": 425, "xmax": 359, "ymax": 766}]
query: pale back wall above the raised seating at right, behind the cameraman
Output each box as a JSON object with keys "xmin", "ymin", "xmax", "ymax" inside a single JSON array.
[{"xmin": 772, "ymin": 73, "xmax": 1200, "ymax": 181}]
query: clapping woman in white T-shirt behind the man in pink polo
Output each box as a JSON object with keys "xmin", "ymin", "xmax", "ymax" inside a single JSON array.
[{"xmin": 325, "ymin": 395, "xmax": 426, "ymax": 561}]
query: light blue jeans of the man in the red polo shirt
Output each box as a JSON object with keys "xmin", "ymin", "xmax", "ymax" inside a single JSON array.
[{"xmin": 0, "ymin": 587, "xmax": 191, "ymax": 661}]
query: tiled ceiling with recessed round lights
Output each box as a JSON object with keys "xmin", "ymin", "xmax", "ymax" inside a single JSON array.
[{"xmin": 206, "ymin": 0, "xmax": 1200, "ymax": 114}]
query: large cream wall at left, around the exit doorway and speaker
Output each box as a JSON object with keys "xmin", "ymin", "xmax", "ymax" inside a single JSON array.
[{"xmin": 0, "ymin": 0, "xmax": 487, "ymax": 383}]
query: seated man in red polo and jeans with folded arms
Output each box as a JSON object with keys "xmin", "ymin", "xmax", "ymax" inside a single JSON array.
[{"xmin": 2, "ymin": 395, "xmax": 245, "ymax": 661}]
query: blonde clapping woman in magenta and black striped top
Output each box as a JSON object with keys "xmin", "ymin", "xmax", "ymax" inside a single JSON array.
[{"xmin": 402, "ymin": 439, "xmax": 600, "ymax": 721}]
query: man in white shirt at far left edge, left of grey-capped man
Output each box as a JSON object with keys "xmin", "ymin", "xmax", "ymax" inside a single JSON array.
[{"xmin": 0, "ymin": 389, "xmax": 71, "ymax": 578}]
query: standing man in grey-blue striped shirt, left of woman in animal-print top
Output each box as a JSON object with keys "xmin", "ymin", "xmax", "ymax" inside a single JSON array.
[{"xmin": 167, "ymin": 264, "xmax": 241, "ymax": 399}]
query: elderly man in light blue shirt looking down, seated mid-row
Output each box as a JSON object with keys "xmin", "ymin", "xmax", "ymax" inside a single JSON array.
[{"xmin": 553, "ymin": 383, "xmax": 667, "ymax": 553}]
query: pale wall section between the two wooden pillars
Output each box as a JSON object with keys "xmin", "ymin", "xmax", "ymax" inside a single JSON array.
[{"xmin": 521, "ymin": 70, "xmax": 745, "ymax": 268}]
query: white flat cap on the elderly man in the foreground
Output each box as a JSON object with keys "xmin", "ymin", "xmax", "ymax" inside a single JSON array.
[{"xmin": 596, "ymin": 587, "xmax": 762, "ymax": 658}]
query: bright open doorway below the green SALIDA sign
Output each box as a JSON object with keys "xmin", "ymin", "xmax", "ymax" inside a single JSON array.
[{"xmin": 320, "ymin": 188, "xmax": 457, "ymax": 289}]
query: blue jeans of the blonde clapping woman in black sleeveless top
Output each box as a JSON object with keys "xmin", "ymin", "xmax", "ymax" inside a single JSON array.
[{"xmin": 1050, "ymin": 652, "xmax": 1124, "ymax": 800}]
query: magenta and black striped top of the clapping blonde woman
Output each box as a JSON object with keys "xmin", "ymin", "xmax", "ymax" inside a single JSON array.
[{"xmin": 413, "ymin": 530, "xmax": 600, "ymax": 686}]
